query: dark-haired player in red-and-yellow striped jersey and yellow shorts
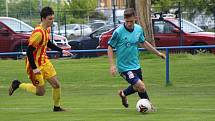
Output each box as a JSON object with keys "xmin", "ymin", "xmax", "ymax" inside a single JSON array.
[{"xmin": 9, "ymin": 7, "xmax": 72, "ymax": 112}]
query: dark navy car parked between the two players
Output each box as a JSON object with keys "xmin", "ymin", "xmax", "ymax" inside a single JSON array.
[{"xmin": 69, "ymin": 25, "xmax": 113, "ymax": 58}]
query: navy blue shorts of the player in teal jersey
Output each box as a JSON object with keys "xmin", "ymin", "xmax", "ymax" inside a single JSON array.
[{"xmin": 120, "ymin": 69, "xmax": 142, "ymax": 85}]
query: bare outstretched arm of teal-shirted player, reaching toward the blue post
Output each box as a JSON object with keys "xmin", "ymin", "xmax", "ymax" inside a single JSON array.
[{"xmin": 140, "ymin": 41, "xmax": 166, "ymax": 59}]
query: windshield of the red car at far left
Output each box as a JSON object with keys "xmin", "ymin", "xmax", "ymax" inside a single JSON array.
[{"xmin": 0, "ymin": 19, "xmax": 33, "ymax": 33}]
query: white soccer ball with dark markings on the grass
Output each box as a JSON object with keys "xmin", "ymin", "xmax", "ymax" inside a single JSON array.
[{"xmin": 136, "ymin": 99, "xmax": 152, "ymax": 113}]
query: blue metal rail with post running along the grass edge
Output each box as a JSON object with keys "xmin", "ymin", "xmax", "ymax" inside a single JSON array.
[{"xmin": 0, "ymin": 45, "xmax": 215, "ymax": 85}]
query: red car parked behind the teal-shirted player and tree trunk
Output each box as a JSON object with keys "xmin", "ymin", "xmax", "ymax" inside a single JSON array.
[{"xmin": 97, "ymin": 18, "xmax": 215, "ymax": 54}]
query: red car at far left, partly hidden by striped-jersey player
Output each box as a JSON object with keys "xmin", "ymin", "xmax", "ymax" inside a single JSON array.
[{"xmin": 0, "ymin": 17, "xmax": 71, "ymax": 58}]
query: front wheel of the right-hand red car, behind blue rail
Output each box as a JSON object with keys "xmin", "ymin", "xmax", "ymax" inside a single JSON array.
[{"xmin": 191, "ymin": 43, "xmax": 211, "ymax": 55}]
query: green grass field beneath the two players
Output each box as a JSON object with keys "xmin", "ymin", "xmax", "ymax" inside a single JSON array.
[{"xmin": 0, "ymin": 54, "xmax": 215, "ymax": 121}]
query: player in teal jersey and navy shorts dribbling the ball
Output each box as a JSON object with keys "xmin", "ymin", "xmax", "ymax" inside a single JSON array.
[{"xmin": 108, "ymin": 8, "xmax": 166, "ymax": 108}]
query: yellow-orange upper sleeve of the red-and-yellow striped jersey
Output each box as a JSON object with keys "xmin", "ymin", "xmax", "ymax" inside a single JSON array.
[{"xmin": 28, "ymin": 31, "xmax": 43, "ymax": 48}]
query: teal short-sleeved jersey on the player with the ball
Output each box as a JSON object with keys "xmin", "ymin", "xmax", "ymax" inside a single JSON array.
[{"xmin": 108, "ymin": 24, "xmax": 145, "ymax": 73}]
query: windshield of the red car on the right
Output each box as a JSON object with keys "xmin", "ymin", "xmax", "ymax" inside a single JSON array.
[{"xmin": 171, "ymin": 19, "xmax": 203, "ymax": 33}]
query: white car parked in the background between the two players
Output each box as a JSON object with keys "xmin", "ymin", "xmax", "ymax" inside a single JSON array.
[{"xmin": 59, "ymin": 24, "xmax": 92, "ymax": 39}]
